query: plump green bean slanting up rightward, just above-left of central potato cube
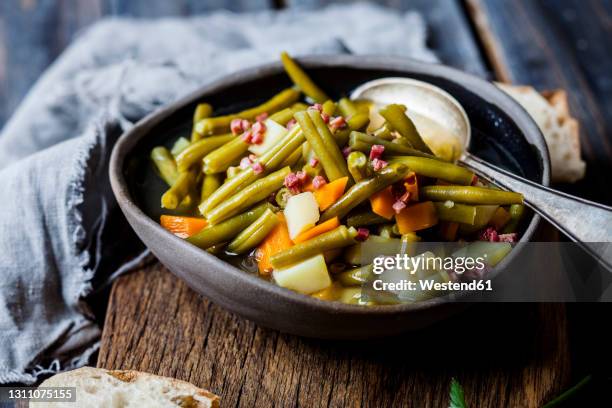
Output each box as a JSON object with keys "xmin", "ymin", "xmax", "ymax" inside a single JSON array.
[{"xmin": 206, "ymin": 167, "xmax": 291, "ymax": 225}]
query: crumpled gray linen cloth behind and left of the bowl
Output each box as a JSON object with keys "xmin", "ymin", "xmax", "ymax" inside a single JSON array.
[{"xmin": 0, "ymin": 4, "xmax": 435, "ymax": 383}]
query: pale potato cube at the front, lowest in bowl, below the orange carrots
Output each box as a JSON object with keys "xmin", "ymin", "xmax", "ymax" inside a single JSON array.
[{"xmin": 272, "ymin": 255, "xmax": 331, "ymax": 295}]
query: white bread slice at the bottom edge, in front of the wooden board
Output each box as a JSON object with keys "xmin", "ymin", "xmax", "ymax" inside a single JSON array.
[{"xmin": 30, "ymin": 367, "xmax": 219, "ymax": 408}]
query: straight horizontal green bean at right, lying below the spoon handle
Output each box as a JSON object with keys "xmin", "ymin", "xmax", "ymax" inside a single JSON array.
[{"xmin": 419, "ymin": 186, "xmax": 523, "ymax": 205}]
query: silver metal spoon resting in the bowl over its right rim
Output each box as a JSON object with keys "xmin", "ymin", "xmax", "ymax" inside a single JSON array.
[{"xmin": 351, "ymin": 78, "xmax": 612, "ymax": 270}]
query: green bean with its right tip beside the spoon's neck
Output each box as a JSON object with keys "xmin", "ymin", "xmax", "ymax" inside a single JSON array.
[{"xmin": 389, "ymin": 156, "xmax": 474, "ymax": 186}]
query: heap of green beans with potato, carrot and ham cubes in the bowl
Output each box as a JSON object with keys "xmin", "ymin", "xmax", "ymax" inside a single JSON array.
[{"xmin": 149, "ymin": 53, "xmax": 525, "ymax": 305}]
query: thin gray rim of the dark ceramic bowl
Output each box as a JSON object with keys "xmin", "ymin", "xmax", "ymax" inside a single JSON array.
[{"xmin": 109, "ymin": 55, "xmax": 550, "ymax": 315}]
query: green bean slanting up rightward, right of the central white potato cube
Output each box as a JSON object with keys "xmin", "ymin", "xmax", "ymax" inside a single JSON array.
[{"xmin": 320, "ymin": 163, "xmax": 409, "ymax": 222}]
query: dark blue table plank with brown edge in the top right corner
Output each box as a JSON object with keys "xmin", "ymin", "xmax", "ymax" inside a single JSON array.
[{"xmin": 467, "ymin": 0, "xmax": 612, "ymax": 205}]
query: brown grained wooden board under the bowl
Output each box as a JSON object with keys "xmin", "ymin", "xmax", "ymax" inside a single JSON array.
[{"xmin": 98, "ymin": 263, "xmax": 569, "ymax": 407}]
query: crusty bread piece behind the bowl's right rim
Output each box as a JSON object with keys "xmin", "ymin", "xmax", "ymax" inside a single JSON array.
[{"xmin": 497, "ymin": 84, "xmax": 586, "ymax": 183}]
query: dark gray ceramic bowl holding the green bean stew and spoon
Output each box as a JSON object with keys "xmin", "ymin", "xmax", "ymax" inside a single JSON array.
[{"xmin": 110, "ymin": 55, "xmax": 550, "ymax": 339}]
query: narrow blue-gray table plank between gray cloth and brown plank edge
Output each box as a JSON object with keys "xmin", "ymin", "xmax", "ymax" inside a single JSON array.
[{"xmin": 286, "ymin": 0, "xmax": 489, "ymax": 77}]
